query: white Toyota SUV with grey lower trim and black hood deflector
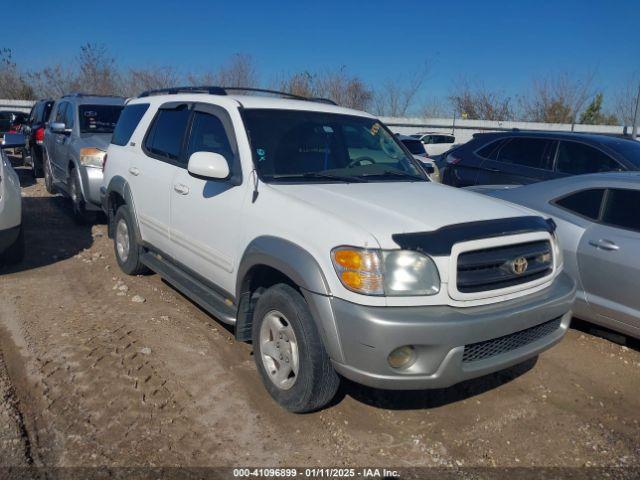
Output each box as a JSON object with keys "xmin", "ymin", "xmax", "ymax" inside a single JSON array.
[{"xmin": 101, "ymin": 87, "xmax": 575, "ymax": 412}]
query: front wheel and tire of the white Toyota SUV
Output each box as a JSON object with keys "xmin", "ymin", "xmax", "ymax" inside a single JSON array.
[{"xmin": 252, "ymin": 283, "xmax": 340, "ymax": 413}]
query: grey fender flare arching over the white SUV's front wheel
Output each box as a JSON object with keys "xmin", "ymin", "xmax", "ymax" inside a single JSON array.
[{"xmin": 236, "ymin": 236, "xmax": 342, "ymax": 361}]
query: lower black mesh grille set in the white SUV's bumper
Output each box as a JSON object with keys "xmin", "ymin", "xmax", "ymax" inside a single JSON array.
[{"xmin": 462, "ymin": 317, "xmax": 562, "ymax": 363}]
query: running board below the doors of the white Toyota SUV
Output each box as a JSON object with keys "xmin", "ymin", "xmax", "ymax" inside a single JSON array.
[{"xmin": 140, "ymin": 251, "xmax": 236, "ymax": 325}]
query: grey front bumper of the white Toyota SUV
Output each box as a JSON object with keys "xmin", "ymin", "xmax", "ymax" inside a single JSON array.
[{"xmin": 328, "ymin": 273, "xmax": 575, "ymax": 390}]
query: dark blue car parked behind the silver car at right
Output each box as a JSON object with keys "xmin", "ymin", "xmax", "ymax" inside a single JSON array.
[{"xmin": 442, "ymin": 131, "xmax": 640, "ymax": 187}]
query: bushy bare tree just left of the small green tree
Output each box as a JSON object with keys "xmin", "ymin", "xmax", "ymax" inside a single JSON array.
[{"xmin": 521, "ymin": 71, "xmax": 595, "ymax": 123}]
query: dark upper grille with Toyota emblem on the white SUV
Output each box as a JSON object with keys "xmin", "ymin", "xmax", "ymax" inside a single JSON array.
[{"xmin": 457, "ymin": 240, "xmax": 553, "ymax": 293}]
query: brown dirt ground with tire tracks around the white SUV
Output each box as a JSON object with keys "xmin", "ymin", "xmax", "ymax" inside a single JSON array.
[{"xmin": 0, "ymin": 158, "xmax": 640, "ymax": 467}]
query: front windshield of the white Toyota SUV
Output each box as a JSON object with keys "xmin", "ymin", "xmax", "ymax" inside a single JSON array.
[{"xmin": 243, "ymin": 109, "xmax": 428, "ymax": 182}]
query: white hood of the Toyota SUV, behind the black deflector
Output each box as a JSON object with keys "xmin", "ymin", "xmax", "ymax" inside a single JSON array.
[{"xmin": 271, "ymin": 182, "xmax": 532, "ymax": 248}]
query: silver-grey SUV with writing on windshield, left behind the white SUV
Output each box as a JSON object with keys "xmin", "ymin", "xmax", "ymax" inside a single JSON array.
[{"xmin": 43, "ymin": 93, "xmax": 125, "ymax": 223}]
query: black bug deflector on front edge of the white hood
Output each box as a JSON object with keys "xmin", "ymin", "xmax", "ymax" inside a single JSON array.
[{"xmin": 391, "ymin": 216, "xmax": 556, "ymax": 256}]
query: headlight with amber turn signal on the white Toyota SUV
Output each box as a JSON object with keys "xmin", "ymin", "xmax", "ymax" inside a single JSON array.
[{"xmin": 331, "ymin": 247, "xmax": 440, "ymax": 296}]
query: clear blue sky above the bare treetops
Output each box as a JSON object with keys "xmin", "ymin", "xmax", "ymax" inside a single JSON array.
[{"xmin": 0, "ymin": 0, "xmax": 640, "ymax": 110}]
